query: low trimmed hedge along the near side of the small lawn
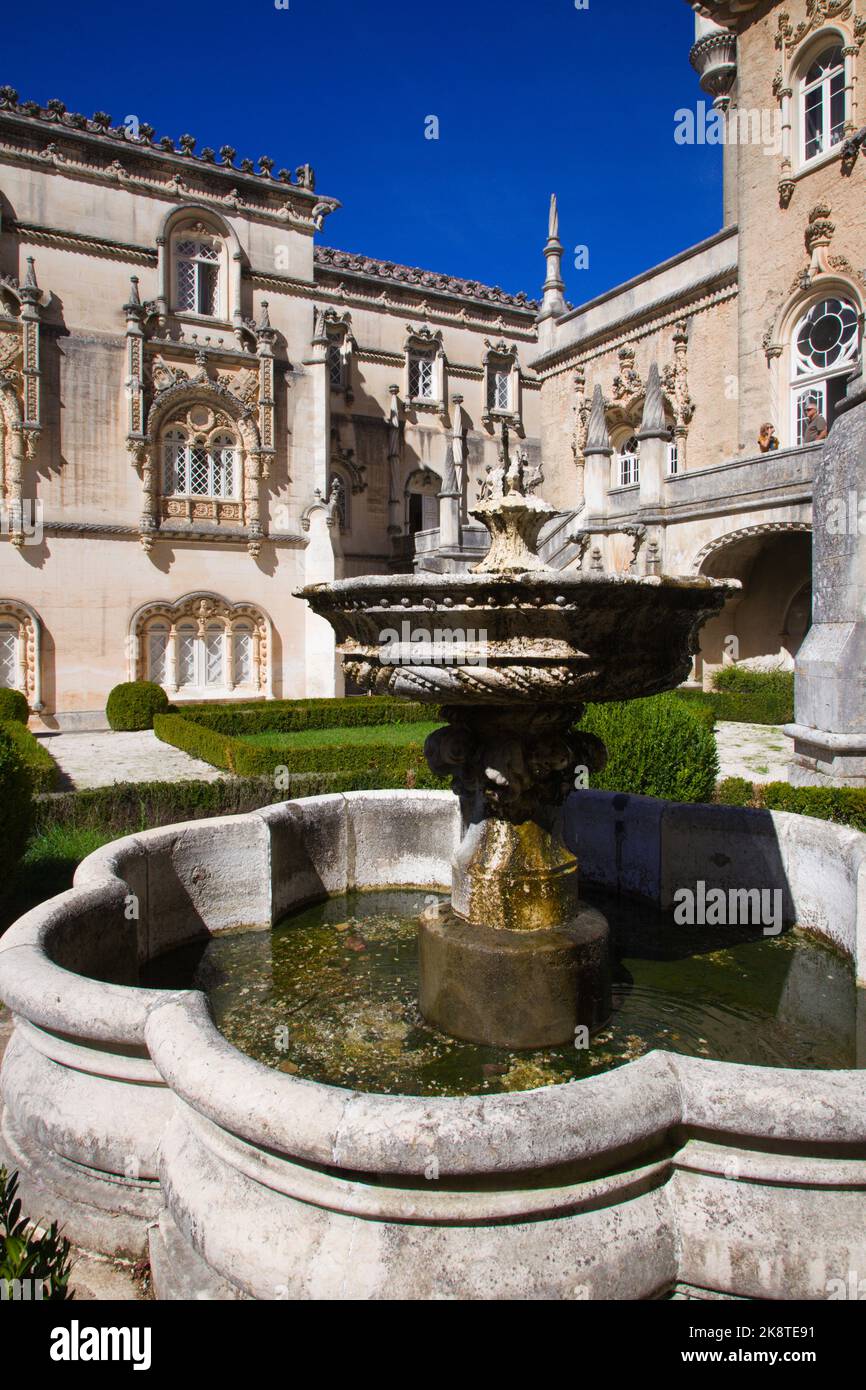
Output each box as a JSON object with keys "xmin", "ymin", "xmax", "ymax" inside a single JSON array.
[{"xmin": 153, "ymin": 708, "xmax": 446, "ymax": 795}]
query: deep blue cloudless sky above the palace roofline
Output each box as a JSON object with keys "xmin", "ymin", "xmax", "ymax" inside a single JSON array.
[{"xmin": 8, "ymin": 0, "xmax": 721, "ymax": 303}]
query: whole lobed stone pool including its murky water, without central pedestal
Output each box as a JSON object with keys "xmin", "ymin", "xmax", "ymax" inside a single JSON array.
[{"xmin": 0, "ymin": 791, "xmax": 866, "ymax": 1300}]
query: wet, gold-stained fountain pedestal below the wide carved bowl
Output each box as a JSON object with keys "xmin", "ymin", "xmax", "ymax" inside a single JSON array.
[{"xmin": 418, "ymin": 703, "xmax": 610, "ymax": 1048}]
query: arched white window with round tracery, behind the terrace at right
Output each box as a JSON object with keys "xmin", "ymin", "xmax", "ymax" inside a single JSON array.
[{"xmin": 791, "ymin": 296, "xmax": 859, "ymax": 445}]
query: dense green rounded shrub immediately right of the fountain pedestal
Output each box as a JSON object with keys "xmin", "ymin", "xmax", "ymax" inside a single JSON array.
[{"xmin": 580, "ymin": 695, "xmax": 719, "ymax": 801}]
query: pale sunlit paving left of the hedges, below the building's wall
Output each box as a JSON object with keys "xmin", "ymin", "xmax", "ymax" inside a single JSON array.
[{"xmin": 39, "ymin": 730, "xmax": 229, "ymax": 791}]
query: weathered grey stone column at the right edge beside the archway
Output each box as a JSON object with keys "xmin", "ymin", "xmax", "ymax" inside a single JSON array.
[{"xmin": 785, "ymin": 361, "xmax": 866, "ymax": 787}]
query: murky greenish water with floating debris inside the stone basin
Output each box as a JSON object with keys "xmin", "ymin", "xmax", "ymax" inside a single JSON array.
[{"xmin": 142, "ymin": 887, "xmax": 856, "ymax": 1095}]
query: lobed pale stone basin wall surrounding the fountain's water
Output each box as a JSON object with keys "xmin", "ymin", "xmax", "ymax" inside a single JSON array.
[{"xmin": 0, "ymin": 792, "xmax": 866, "ymax": 1298}]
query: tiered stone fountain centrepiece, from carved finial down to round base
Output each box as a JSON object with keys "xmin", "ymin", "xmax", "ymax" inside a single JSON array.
[{"xmin": 302, "ymin": 431, "xmax": 737, "ymax": 1048}]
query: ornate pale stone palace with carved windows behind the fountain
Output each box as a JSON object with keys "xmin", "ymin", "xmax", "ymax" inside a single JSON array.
[{"xmin": 0, "ymin": 0, "xmax": 866, "ymax": 727}]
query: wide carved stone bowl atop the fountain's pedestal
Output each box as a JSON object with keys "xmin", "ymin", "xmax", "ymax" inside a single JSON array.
[{"xmin": 299, "ymin": 570, "xmax": 740, "ymax": 705}]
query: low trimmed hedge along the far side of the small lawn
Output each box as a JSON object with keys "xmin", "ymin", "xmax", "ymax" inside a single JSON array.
[{"xmin": 181, "ymin": 695, "xmax": 439, "ymax": 735}]
